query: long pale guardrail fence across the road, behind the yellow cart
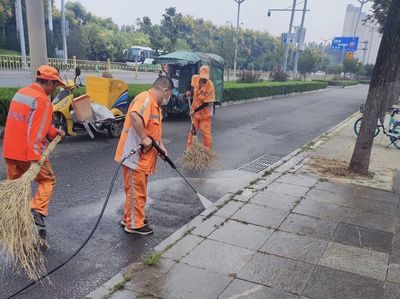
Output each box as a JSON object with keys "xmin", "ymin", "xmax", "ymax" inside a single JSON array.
[{"xmin": 0, "ymin": 55, "xmax": 161, "ymax": 72}]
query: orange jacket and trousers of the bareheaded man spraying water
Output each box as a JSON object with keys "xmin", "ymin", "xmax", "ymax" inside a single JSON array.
[{"xmin": 115, "ymin": 91, "xmax": 162, "ymax": 229}]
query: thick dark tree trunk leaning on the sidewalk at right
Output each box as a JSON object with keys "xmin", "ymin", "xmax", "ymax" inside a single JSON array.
[{"xmin": 350, "ymin": 0, "xmax": 400, "ymax": 175}]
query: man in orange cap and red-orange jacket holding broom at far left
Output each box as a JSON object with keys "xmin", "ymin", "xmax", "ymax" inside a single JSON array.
[{"xmin": 3, "ymin": 65, "xmax": 66, "ymax": 227}]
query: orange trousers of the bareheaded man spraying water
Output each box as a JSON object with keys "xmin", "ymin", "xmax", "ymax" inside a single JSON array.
[{"xmin": 122, "ymin": 165, "xmax": 149, "ymax": 228}]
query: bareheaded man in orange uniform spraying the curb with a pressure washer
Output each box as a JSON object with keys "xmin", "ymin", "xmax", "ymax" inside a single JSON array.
[{"xmin": 115, "ymin": 76, "xmax": 174, "ymax": 235}]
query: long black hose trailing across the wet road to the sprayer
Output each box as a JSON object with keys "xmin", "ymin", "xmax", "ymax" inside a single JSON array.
[{"xmin": 7, "ymin": 146, "xmax": 142, "ymax": 299}]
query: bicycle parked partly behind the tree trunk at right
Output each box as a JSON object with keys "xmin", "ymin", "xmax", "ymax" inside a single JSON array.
[{"xmin": 353, "ymin": 104, "xmax": 400, "ymax": 149}]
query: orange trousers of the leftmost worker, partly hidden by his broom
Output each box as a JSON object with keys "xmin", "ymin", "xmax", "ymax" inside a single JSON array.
[{"xmin": 5, "ymin": 158, "xmax": 56, "ymax": 216}]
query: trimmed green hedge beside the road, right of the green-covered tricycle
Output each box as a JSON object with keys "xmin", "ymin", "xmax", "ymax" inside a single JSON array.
[{"xmin": 223, "ymin": 81, "xmax": 328, "ymax": 101}]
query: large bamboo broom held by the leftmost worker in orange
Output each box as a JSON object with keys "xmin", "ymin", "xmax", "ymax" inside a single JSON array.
[{"xmin": 0, "ymin": 136, "xmax": 61, "ymax": 280}]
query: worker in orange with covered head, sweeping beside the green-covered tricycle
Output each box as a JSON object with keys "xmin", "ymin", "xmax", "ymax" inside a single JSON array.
[{"xmin": 186, "ymin": 65, "xmax": 215, "ymax": 149}]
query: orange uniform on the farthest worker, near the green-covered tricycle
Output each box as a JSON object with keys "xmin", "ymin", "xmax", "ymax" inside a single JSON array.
[{"xmin": 186, "ymin": 75, "xmax": 215, "ymax": 149}]
